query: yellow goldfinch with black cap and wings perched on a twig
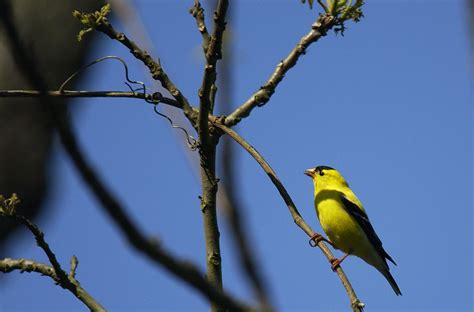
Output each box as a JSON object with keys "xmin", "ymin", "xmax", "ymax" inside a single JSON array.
[{"xmin": 304, "ymin": 166, "xmax": 402, "ymax": 296}]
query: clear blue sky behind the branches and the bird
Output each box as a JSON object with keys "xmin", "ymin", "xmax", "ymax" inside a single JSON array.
[{"xmin": 0, "ymin": 0, "xmax": 473, "ymax": 311}]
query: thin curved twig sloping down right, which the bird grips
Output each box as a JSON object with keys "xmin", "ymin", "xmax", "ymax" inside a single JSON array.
[{"xmin": 214, "ymin": 119, "xmax": 364, "ymax": 312}]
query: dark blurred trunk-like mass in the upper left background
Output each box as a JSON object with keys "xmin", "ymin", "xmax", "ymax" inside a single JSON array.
[{"xmin": 0, "ymin": 0, "xmax": 103, "ymax": 258}]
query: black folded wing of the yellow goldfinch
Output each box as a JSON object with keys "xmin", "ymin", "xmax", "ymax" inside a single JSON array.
[{"xmin": 340, "ymin": 193, "xmax": 397, "ymax": 265}]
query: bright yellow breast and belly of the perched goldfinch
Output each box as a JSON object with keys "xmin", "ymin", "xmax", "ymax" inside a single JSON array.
[{"xmin": 315, "ymin": 194, "xmax": 373, "ymax": 261}]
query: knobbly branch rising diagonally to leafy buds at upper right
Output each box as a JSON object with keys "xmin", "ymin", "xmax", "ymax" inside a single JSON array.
[{"xmin": 225, "ymin": 14, "xmax": 337, "ymax": 127}]
